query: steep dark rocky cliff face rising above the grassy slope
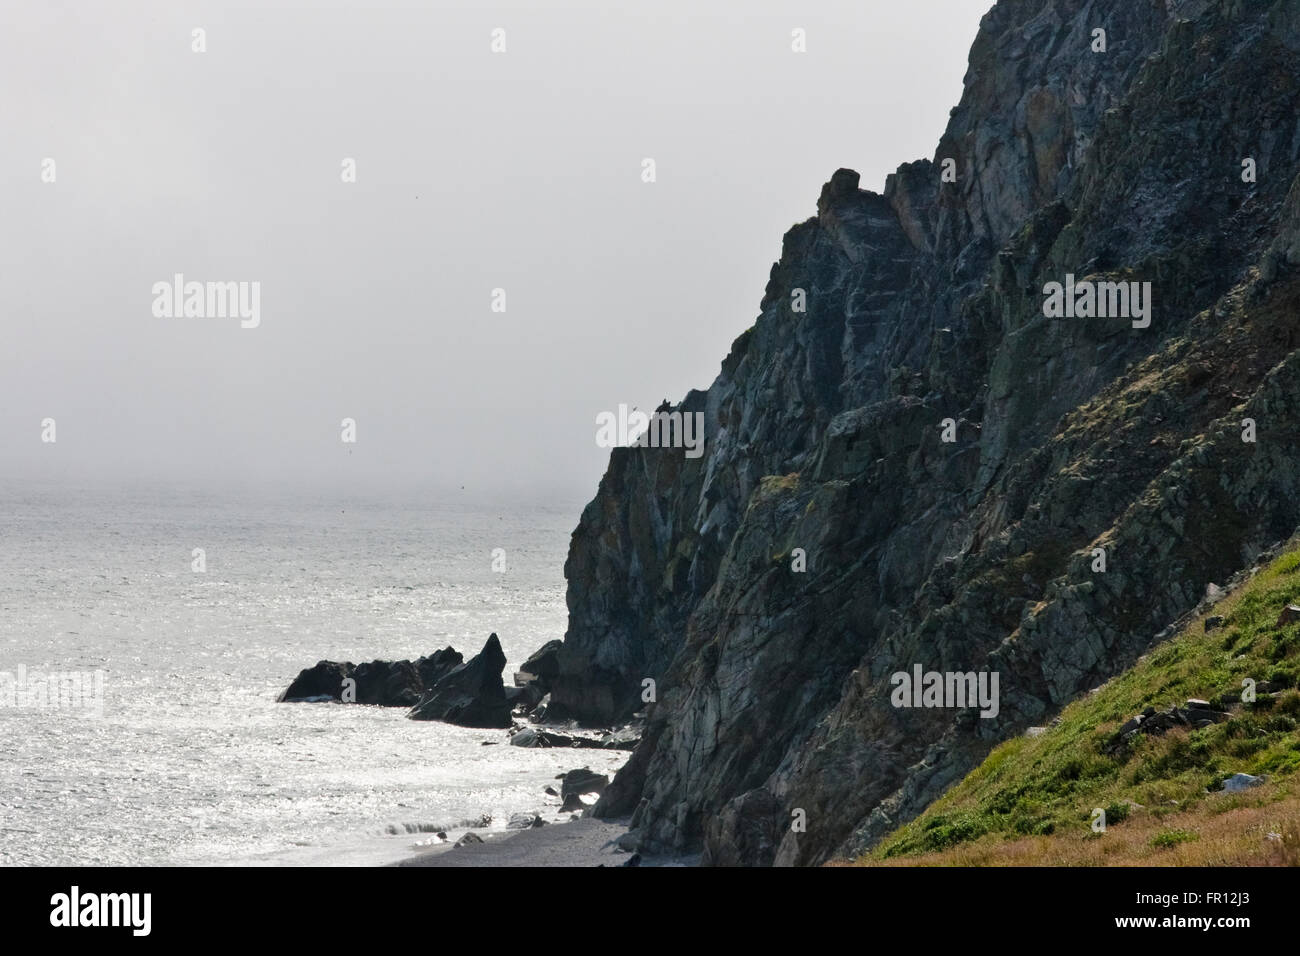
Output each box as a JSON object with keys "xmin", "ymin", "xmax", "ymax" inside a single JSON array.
[{"xmin": 555, "ymin": 0, "xmax": 1300, "ymax": 864}]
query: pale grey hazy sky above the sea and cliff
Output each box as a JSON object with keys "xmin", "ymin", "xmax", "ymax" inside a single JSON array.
[{"xmin": 0, "ymin": 0, "xmax": 992, "ymax": 498}]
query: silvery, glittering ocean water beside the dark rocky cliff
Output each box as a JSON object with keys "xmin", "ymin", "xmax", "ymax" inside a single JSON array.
[{"xmin": 0, "ymin": 484, "xmax": 627, "ymax": 865}]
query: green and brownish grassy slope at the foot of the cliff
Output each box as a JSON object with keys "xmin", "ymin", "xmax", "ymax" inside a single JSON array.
[{"xmin": 857, "ymin": 541, "xmax": 1300, "ymax": 866}]
